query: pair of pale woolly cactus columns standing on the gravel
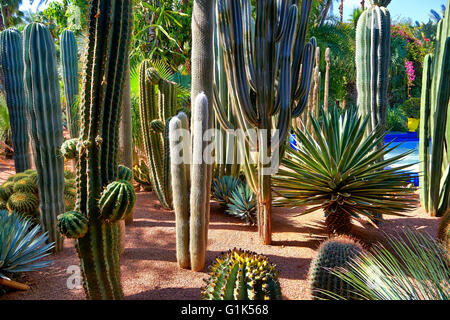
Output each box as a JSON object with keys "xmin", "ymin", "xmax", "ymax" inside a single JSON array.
[{"xmin": 169, "ymin": 93, "xmax": 209, "ymax": 271}]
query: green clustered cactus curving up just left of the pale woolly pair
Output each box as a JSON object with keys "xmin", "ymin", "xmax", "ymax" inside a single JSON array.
[{"xmin": 139, "ymin": 60, "xmax": 177, "ymax": 209}]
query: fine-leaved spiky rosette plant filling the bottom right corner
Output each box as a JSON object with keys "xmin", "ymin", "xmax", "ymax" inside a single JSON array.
[{"xmin": 324, "ymin": 230, "xmax": 450, "ymax": 300}]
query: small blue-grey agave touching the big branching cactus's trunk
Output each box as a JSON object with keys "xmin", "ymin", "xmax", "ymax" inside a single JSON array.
[{"xmin": 226, "ymin": 184, "xmax": 257, "ymax": 225}]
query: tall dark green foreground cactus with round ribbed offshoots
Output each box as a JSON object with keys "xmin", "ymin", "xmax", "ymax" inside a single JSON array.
[{"xmin": 64, "ymin": 0, "xmax": 135, "ymax": 300}]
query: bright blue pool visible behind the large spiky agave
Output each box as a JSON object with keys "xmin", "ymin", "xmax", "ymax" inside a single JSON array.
[{"xmin": 290, "ymin": 132, "xmax": 419, "ymax": 186}]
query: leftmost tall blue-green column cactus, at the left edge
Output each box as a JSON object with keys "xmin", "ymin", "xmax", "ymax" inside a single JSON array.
[{"xmin": 0, "ymin": 28, "xmax": 31, "ymax": 172}]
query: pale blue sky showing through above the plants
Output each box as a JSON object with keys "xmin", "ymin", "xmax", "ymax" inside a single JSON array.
[{"xmin": 21, "ymin": 0, "xmax": 447, "ymax": 22}]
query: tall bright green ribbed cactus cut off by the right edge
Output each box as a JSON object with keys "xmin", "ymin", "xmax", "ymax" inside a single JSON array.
[{"xmin": 419, "ymin": 1, "xmax": 450, "ymax": 216}]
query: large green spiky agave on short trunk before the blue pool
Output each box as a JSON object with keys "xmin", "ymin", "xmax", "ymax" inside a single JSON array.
[{"xmin": 273, "ymin": 108, "xmax": 414, "ymax": 234}]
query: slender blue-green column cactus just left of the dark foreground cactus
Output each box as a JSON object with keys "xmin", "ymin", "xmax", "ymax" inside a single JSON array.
[{"xmin": 60, "ymin": 30, "xmax": 79, "ymax": 138}]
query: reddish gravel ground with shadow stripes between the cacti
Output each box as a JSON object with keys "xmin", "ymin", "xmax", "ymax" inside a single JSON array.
[{"xmin": 0, "ymin": 158, "xmax": 439, "ymax": 300}]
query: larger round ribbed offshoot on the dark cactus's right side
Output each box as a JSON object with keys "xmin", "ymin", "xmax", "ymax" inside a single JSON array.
[{"xmin": 99, "ymin": 180, "xmax": 136, "ymax": 223}]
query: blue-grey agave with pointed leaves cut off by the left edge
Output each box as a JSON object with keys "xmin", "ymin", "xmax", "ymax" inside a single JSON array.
[{"xmin": 0, "ymin": 210, "xmax": 54, "ymax": 279}]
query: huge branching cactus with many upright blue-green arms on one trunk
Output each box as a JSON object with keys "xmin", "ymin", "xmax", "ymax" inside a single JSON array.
[{"xmin": 216, "ymin": 0, "xmax": 315, "ymax": 244}]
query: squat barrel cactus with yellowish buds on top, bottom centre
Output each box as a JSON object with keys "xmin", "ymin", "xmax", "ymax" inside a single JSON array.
[{"xmin": 202, "ymin": 249, "xmax": 281, "ymax": 300}]
